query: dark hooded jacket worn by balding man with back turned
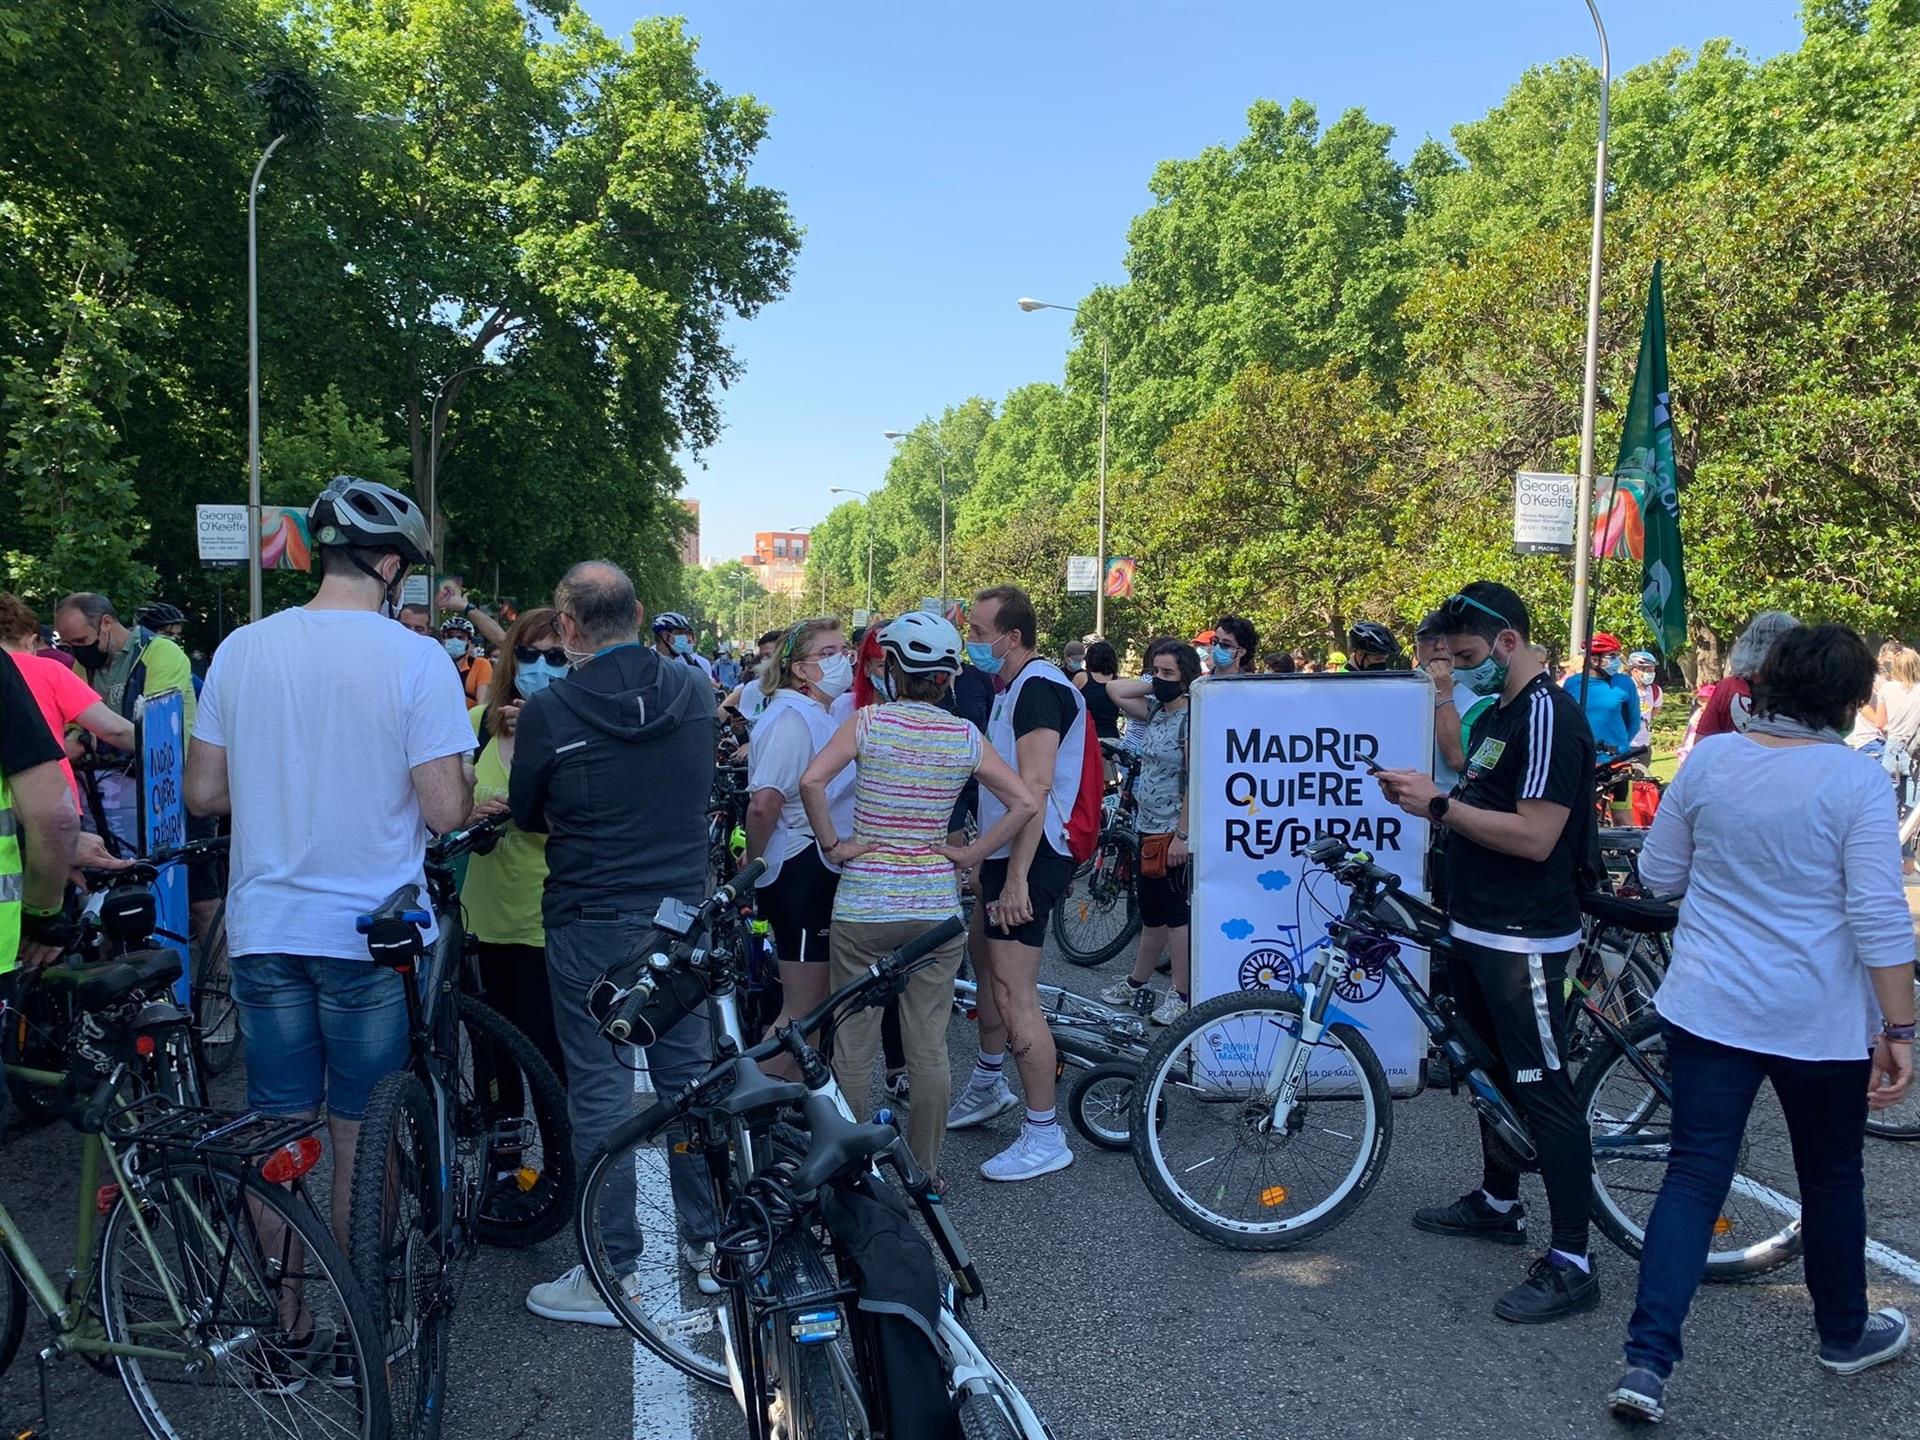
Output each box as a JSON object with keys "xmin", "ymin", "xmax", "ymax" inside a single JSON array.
[{"xmin": 507, "ymin": 643, "xmax": 714, "ymax": 927}]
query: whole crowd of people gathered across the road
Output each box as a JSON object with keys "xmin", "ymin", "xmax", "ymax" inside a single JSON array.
[{"xmin": 0, "ymin": 476, "xmax": 1920, "ymax": 1419}]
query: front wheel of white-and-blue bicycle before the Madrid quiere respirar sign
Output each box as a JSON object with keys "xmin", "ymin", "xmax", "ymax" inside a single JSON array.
[{"xmin": 1127, "ymin": 991, "xmax": 1394, "ymax": 1250}]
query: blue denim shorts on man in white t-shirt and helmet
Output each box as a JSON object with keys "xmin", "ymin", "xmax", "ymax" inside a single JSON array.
[{"xmin": 232, "ymin": 954, "xmax": 409, "ymax": 1119}]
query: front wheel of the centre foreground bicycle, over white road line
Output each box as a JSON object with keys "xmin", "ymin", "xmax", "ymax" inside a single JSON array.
[{"xmin": 574, "ymin": 1117, "xmax": 728, "ymax": 1388}]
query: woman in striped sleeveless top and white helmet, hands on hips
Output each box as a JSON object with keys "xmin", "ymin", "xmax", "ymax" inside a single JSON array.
[{"xmin": 801, "ymin": 612, "xmax": 1037, "ymax": 1175}]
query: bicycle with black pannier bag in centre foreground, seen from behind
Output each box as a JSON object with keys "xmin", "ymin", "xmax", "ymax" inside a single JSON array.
[{"xmin": 580, "ymin": 902, "xmax": 1050, "ymax": 1440}]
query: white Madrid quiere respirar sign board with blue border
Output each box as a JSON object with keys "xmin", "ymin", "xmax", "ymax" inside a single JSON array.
[{"xmin": 1188, "ymin": 672, "xmax": 1434, "ymax": 1094}]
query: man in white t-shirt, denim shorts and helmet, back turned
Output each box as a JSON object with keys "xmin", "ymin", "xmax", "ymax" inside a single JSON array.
[{"xmin": 186, "ymin": 476, "xmax": 474, "ymax": 1242}]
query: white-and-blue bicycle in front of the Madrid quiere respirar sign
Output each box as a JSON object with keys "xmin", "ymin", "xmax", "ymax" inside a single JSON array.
[{"xmin": 1131, "ymin": 835, "xmax": 1799, "ymax": 1279}]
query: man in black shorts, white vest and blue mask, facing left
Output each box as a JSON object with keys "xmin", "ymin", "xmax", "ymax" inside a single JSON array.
[{"xmin": 947, "ymin": 586, "xmax": 1089, "ymax": 1181}]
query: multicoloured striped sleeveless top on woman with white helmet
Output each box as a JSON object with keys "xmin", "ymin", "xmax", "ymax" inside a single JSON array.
[{"xmin": 833, "ymin": 701, "xmax": 985, "ymax": 924}]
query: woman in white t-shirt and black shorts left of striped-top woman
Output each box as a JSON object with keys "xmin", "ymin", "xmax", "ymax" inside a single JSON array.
[{"xmin": 745, "ymin": 616, "xmax": 854, "ymax": 1068}]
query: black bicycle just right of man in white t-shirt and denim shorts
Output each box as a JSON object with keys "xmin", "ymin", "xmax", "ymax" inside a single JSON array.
[{"xmin": 348, "ymin": 818, "xmax": 574, "ymax": 1440}]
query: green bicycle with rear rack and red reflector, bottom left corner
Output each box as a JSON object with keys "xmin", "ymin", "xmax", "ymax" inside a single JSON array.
[{"xmin": 0, "ymin": 950, "xmax": 388, "ymax": 1440}]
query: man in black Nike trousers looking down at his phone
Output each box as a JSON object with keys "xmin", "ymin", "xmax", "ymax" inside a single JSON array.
[{"xmin": 1379, "ymin": 580, "xmax": 1599, "ymax": 1325}]
